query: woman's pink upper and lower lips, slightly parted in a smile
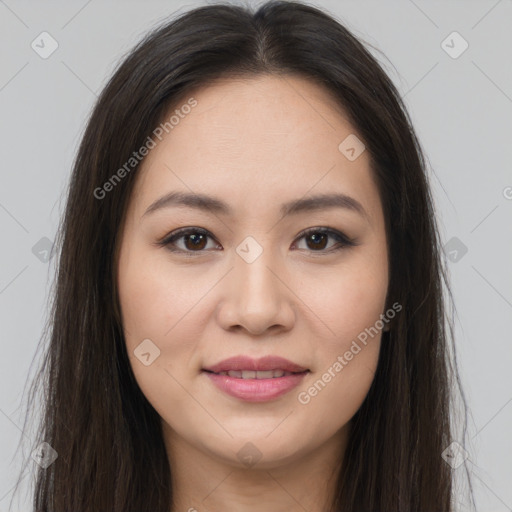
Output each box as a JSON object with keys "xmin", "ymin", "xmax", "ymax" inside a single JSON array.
[{"xmin": 203, "ymin": 355, "xmax": 309, "ymax": 402}]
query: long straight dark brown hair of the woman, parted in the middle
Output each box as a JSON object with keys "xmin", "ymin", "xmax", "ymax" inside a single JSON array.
[{"xmin": 12, "ymin": 1, "xmax": 474, "ymax": 512}]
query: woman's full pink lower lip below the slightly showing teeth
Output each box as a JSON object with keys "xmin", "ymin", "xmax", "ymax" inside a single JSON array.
[{"xmin": 203, "ymin": 371, "xmax": 308, "ymax": 402}]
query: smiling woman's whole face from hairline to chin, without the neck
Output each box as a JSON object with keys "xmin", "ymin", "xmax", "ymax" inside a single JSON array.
[{"xmin": 117, "ymin": 76, "xmax": 388, "ymax": 467}]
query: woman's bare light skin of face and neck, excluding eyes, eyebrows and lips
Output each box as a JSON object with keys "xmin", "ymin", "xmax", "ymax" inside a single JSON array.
[{"xmin": 117, "ymin": 75, "xmax": 388, "ymax": 512}]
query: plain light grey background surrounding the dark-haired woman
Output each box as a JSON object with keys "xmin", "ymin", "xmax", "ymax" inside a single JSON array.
[{"xmin": 0, "ymin": 0, "xmax": 512, "ymax": 512}]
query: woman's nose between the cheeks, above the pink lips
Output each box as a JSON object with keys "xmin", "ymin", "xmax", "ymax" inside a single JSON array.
[{"xmin": 217, "ymin": 246, "xmax": 298, "ymax": 336}]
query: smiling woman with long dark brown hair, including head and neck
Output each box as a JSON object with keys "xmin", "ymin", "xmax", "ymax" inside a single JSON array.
[{"xmin": 15, "ymin": 1, "xmax": 472, "ymax": 512}]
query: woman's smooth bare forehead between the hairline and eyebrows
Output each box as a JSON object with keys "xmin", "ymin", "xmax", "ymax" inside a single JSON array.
[{"xmin": 130, "ymin": 75, "xmax": 382, "ymax": 221}]
